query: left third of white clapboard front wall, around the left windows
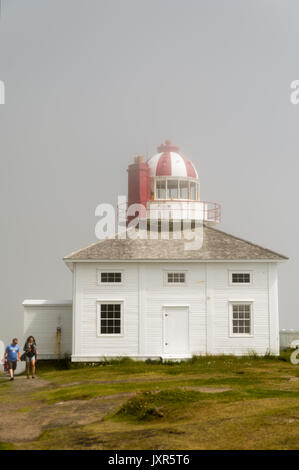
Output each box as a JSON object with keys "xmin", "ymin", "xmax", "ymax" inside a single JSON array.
[{"xmin": 73, "ymin": 263, "xmax": 139, "ymax": 359}]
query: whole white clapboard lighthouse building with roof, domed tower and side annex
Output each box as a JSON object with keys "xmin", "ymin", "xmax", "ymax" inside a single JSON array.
[{"xmin": 24, "ymin": 141, "xmax": 287, "ymax": 362}]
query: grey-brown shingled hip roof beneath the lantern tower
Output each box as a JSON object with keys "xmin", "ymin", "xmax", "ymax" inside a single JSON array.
[{"xmin": 64, "ymin": 226, "xmax": 288, "ymax": 262}]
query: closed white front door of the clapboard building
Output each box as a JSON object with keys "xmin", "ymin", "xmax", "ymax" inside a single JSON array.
[{"xmin": 163, "ymin": 307, "xmax": 189, "ymax": 357}]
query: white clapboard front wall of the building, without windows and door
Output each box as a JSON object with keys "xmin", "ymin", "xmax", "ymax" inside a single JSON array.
[{"xmin": 73, "ymin": 262, "xmax": 279, "ymax": 360}]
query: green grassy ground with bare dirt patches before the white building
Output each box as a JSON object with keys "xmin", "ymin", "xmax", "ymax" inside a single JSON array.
[{"xmin": 0, "ymin": 353, "xmax": 299, "ymax": 450}]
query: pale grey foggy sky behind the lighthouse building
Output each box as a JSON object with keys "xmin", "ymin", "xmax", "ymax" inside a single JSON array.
[{"xmin": 0, "ymin": 0, "xmax": 299, "ymax": 342}]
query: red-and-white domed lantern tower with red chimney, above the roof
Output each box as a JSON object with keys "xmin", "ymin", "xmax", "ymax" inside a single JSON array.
[{"xmin": 126, "ymin": 140, "xmax": 221, "ymax": 227}]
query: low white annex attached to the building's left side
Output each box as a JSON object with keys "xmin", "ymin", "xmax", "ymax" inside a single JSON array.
[{"xmin": 22, "ymin": 300, "xmax": 72, "ymax": 359}]
